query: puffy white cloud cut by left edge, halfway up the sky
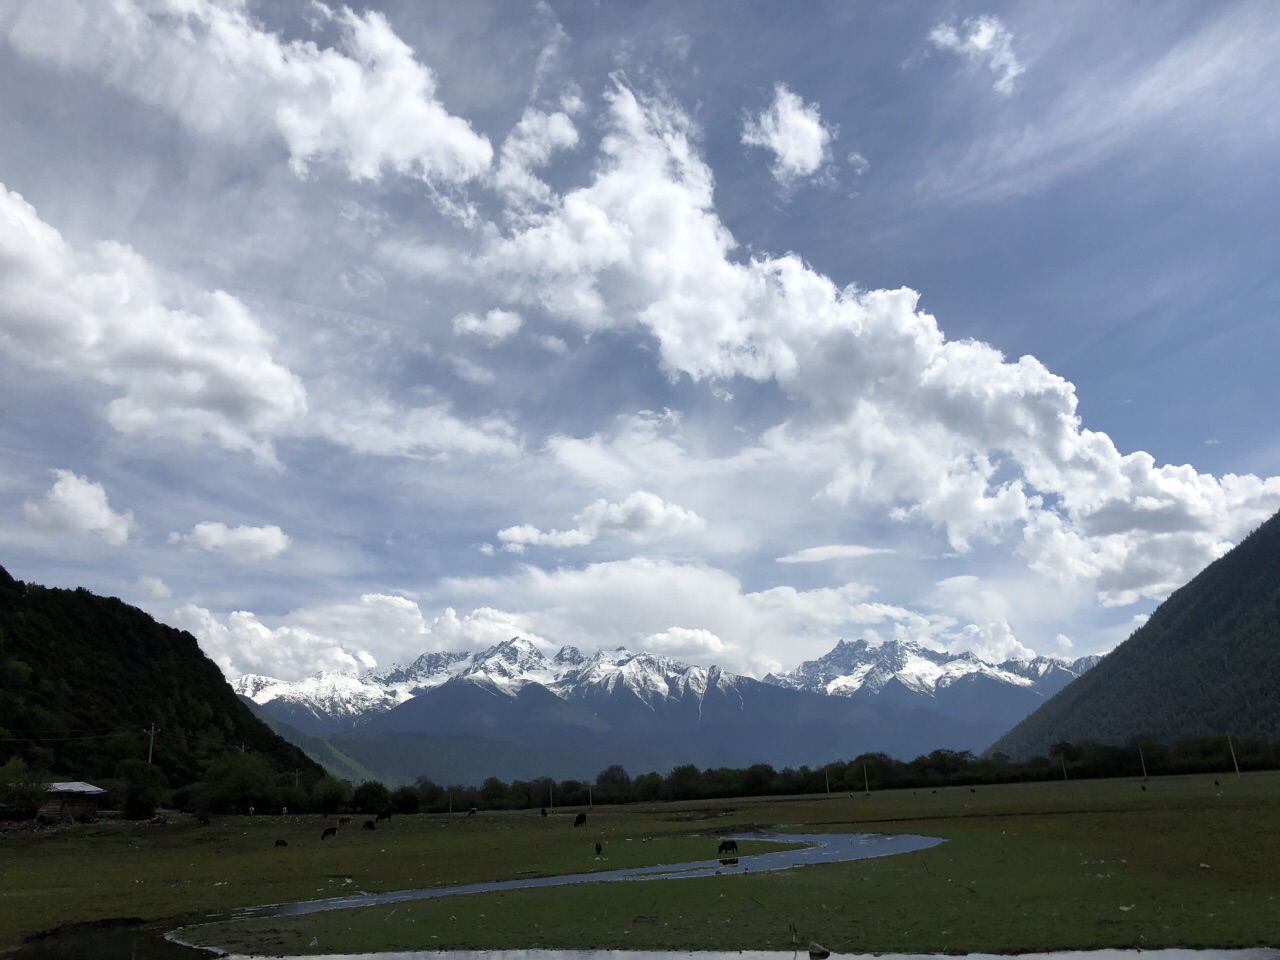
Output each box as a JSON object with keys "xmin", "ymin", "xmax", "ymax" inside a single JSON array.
[{"xmin": 0, "ymin": 184, "xmax": 307, "ymax": 461}]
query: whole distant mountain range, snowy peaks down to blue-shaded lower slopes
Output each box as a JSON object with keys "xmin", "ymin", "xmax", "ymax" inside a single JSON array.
[{"xmin": 233, "ymin": 637, "xmax": 1097, "ymax": 782}]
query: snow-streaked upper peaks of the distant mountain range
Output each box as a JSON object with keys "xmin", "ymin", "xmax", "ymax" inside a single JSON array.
[{"xmin": 233, "ymin": 636, "xmax": 1096, "ymax": 736}]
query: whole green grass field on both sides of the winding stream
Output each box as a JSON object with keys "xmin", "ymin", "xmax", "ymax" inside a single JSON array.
[{"xmin": 0, "ymin": 773, "xmax": 1280, "ymax": 954}]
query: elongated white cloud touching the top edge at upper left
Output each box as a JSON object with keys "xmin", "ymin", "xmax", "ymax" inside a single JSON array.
[{"xmin": 6, "ymin": 0, "xmax": 493, "ymax": 186}]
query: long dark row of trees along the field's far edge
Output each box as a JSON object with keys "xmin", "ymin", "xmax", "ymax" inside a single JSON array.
[{"xmin": 10, "ymin": 735, "xmax": 1280, "ymax": 818}]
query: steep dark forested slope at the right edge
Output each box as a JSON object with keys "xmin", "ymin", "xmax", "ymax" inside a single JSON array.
[{"xmin": 989, "ymin": 515, "xmax": 1280, "ymax": 759}]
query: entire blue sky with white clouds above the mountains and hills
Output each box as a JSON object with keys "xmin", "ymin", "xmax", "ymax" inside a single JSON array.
[{"xmin": 0, "ymin": 0, "xmax": 1280, "ymax": 680}]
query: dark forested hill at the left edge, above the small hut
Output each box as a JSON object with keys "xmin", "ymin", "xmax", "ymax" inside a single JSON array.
[{"xmin": 0, "ymin": 567, "xmax": 320, "ymax": 786}]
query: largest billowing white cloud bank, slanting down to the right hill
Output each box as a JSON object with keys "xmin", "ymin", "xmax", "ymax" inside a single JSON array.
[{"xmin": 472, "ymin": 84, "xmax": 1280, "ymax": 603}]
